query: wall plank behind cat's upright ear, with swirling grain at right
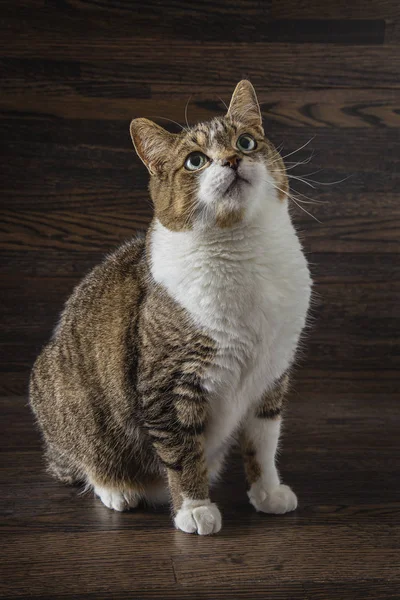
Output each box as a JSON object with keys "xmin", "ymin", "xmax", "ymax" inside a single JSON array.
[{"xmin": 0, "ymin": 88, "xmax": 400, "ymax": 130}]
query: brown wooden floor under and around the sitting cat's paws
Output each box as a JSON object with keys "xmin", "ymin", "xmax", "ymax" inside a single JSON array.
[{"xmin": 0, "ymin": 392, "xmax": 400, "ymax": 600}]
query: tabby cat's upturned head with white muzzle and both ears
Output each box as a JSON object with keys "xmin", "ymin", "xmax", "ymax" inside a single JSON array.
[{"xmin": 130, "ymin": 80, "xmax": 288, "ymax": 231}]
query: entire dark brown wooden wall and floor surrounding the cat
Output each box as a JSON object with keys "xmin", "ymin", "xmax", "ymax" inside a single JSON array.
[{"xmin": 0, "ymin": 0, "xmax": 400, "ymax": 600}]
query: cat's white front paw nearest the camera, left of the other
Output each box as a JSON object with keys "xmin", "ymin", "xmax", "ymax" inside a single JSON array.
[{"xmin": 174, "ymin": 500, "xmax": 222, "ymax": 535}]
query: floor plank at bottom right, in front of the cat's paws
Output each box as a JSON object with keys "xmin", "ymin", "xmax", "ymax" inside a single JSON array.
[{"xmin": 173, "ymin": 524, "xmax": 400, "ymax": 586}]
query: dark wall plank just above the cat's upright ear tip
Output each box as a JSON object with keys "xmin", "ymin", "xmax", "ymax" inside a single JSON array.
[{"xmin": 3, "ymin": 40, "xmax": 400, "ymax": 89}]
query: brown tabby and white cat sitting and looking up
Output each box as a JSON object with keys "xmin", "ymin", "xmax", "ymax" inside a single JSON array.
[{"xmin": 30, "ymin": 80, "xmax": 312, "ymax": 535}]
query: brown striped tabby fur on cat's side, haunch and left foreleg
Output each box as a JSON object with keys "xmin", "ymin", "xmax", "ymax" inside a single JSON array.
[{"xmin": 30, "ymin": 239, "xmax": 215, "ymax": 510}]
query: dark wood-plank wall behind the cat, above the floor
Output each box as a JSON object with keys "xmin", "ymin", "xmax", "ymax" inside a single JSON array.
[{"xmin": 0, "ymin": 0, "xmax": 400, "ymax": 395}]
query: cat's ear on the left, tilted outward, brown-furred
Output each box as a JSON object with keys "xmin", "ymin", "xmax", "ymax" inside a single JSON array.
[{"xmin": 130, "ymin": 119, "xmax": 175, "ymax": 175}]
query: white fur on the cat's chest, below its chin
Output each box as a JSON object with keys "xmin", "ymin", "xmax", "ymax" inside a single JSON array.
[{"xmin": 151, "ymin": 204, "xmax": 311, "ymax": 458}]
